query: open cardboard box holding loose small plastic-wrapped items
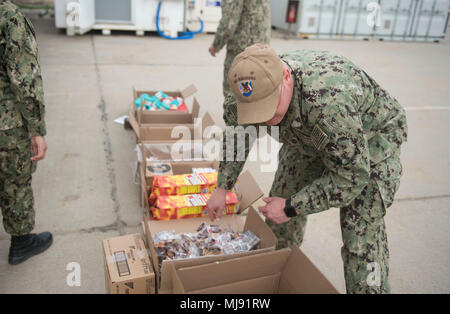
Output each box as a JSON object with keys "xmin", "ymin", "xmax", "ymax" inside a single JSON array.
[{"xmin": 144, "ymin": 171, "xmax": 277, "ymax": 294}]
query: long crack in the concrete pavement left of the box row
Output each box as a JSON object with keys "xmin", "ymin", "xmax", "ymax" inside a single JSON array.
[{"xmin": 91, "ymin": 35, "xmax": 124, "ymax": 235}]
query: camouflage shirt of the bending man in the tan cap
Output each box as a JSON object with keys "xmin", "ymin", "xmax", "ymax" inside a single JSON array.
[{"xmin": 218, "ymin": 50, "xmax": 407, "ymax": 215}]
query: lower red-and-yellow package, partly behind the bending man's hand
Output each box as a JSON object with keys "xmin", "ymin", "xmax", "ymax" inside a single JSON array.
[{"xmin": 150, "ymin": 191, "xmax": 239, "ymax": 220}]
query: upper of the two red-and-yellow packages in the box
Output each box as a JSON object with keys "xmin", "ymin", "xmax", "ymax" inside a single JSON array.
[{"xmin": 150, "ymin": 172, "xmax": 217, "ymax": 204}]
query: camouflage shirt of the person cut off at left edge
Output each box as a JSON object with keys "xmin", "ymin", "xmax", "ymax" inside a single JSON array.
[{"xmin": 0, "ymin": 1, "xmax": 46, "ymax": 136}]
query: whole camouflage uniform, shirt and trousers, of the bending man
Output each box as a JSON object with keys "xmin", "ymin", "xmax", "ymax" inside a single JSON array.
[{"xmin": 218, "ymin": 51, "xmax": 407, "ymax": 293}]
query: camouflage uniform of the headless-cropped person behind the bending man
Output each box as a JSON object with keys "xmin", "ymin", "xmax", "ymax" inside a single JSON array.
[{"xmin": 213, "ymin": 0, "xmax": 271, "ymax": 96}]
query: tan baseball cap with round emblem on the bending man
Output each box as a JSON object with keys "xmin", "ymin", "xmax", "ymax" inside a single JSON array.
[{"xmin": 228, "ymin": 44, "xmax": 283, "ymax": 124}]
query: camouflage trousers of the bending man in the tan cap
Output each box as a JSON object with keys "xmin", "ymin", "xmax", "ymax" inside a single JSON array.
[{"xmin": 267, "ymin": 145, "xmax": 401, "ymax": 293}]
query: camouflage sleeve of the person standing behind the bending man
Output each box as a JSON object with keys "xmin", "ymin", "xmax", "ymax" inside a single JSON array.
[{"xmin": 213, "ymin": 0, "xmax": 244, "ymax": 52}]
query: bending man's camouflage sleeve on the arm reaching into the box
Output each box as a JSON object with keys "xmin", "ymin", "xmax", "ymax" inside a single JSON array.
[{"xmin": 217, "ymin": 93, "xmax": 257, "ymax": 190}]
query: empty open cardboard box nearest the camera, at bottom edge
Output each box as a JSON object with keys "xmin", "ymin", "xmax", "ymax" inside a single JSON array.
[{"xmin": 172, "ymin": 246, "xmax": 338, "ymax": 294}]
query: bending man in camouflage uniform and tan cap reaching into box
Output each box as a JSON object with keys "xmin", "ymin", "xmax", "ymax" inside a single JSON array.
[{"xmin": 208, "ymin": 45, "xmax": 407, "ymax": 293}]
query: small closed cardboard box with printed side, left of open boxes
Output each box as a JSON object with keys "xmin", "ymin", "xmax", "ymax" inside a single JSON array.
[{"xmin": 103, "ymin": 234, "xmax": 156, "ymax": 294}]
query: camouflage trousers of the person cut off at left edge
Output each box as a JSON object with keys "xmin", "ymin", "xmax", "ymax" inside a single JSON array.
[{"xmin": 0, "ymin": 127, "xmax": 36, "ymax": 236}]
